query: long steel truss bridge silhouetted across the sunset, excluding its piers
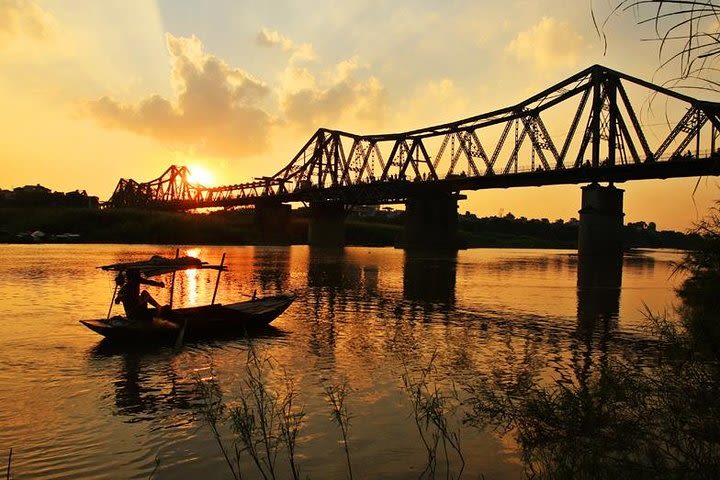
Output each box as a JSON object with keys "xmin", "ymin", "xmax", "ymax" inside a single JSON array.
[{"xmin": 107, "ymin": 65, "xmax": 720, "ymax": 210}]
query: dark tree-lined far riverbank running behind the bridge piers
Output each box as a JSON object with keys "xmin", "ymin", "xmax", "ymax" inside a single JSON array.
[{"xmin": 0, "ymin": 205, "xmax": 700, "ymax": 250}]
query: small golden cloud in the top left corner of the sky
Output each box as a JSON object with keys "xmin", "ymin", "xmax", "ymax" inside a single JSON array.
[{"xmin": 0, "ymin": 0, "xmax": 55, "ymax": 47}]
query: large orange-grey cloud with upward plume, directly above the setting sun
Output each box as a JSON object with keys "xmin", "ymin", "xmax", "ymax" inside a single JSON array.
[{"xmin": 85, "ymin": 34, "xmax": 272, "ymax": 156}]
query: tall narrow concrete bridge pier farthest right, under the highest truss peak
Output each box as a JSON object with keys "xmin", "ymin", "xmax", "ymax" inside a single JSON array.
[{"xmin": 578, "ymin": 183, "xmax": 625, "ymax": 259}]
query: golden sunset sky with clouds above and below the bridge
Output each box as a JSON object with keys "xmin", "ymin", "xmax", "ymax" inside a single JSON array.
[{"xmin": 0, "ymin": 0, "xmax": 720, "ymax": 229}]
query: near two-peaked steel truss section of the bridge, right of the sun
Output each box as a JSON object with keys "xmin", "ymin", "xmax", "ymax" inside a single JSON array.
[{"xmin": 273, "ymin": 65, "xmax": 720, "ymax": 189}]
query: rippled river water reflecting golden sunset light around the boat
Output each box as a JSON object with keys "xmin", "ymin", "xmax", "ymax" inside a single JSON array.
[{"xmin": 0, "ymin": 245, "xmax": 680, "ymax": 480}]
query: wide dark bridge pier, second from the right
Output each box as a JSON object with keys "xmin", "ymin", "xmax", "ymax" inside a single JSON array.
[{"xmin": 397, "ymin": 192, "xmax": 467, "ymax": 250}]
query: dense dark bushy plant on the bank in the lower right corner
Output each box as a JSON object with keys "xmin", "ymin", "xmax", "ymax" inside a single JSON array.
[{"xmin": 466, "ymin": 306, "xmax": 720, "ymax": 479}]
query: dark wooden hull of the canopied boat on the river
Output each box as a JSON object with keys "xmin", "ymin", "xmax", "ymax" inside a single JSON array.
[{"xmin": 80, "ymin": 295, "xmax": 295, "ymax": 342}]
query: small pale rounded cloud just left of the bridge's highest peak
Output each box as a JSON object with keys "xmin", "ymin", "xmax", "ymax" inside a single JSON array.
[{"xmin": 507, "ymin": 17, "xmax": 585, "ymax": 68}]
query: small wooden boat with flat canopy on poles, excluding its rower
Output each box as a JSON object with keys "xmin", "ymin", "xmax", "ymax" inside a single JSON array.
[{"xmin": 80, "ymin": 254, "xmax": 295, "ymax": 342}]
